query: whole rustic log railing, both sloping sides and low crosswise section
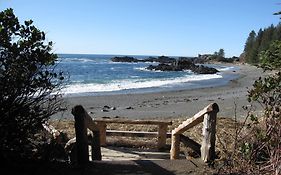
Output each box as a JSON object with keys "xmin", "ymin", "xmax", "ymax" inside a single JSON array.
[{"xmin": 72, "ymin": 103, "xmax": 219, "ymax": 165}]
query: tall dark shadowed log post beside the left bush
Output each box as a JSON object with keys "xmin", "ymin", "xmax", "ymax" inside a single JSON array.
[{"xmin": 71, "ymin": 105, "xmax": 89, "ymax": 165}]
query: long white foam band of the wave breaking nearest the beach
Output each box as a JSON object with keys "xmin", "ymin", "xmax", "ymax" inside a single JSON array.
[{"xmin": 62, "ymin": 74, "xmax": 222, "ymax": 94}]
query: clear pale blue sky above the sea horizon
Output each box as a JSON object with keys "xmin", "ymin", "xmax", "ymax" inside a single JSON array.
[{"xmin": 0, "ymin": 0, "xmax": 281, "ymax": 57}]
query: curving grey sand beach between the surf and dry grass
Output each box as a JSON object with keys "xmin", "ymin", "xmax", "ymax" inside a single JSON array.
[{"xmin": 51, "ymin": 64, "xmax": 263, "ymax": 120}]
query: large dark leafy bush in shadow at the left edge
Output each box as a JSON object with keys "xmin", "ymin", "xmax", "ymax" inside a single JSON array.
[{"xmin": 0, "ymin": 9, "xmax": 64, "ymax": 161}]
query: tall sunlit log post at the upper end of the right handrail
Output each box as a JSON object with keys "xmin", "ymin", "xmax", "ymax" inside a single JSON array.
[{"xmin": 201, "ymin": 104, "xmax": 219, "ymax": 162}]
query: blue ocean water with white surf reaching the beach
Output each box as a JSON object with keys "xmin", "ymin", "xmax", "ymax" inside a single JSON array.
[{"xmin": 57, "ymin": 54, "xmax": 238, "ymax": 96}]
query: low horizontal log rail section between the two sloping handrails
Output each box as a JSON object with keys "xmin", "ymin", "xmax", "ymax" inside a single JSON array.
[{"xmin": 94, "ymin": 119, "xmax": 172, "ymax": 150}]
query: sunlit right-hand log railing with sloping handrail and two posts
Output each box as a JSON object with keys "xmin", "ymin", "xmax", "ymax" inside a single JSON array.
[{"xmin": 170, "ymin": 103, "xmax": 219, "ymax": 162}]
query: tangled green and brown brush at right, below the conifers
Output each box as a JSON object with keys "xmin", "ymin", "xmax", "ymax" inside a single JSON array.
[{"xmin": 218, "ymin": 41, "xmax": 281, "ymax": 175}]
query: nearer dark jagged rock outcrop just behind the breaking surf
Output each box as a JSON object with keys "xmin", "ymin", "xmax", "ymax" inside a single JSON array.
[{"xmin": 147, "ymin": 60, "xmax": 219, "ymax": 74}]
